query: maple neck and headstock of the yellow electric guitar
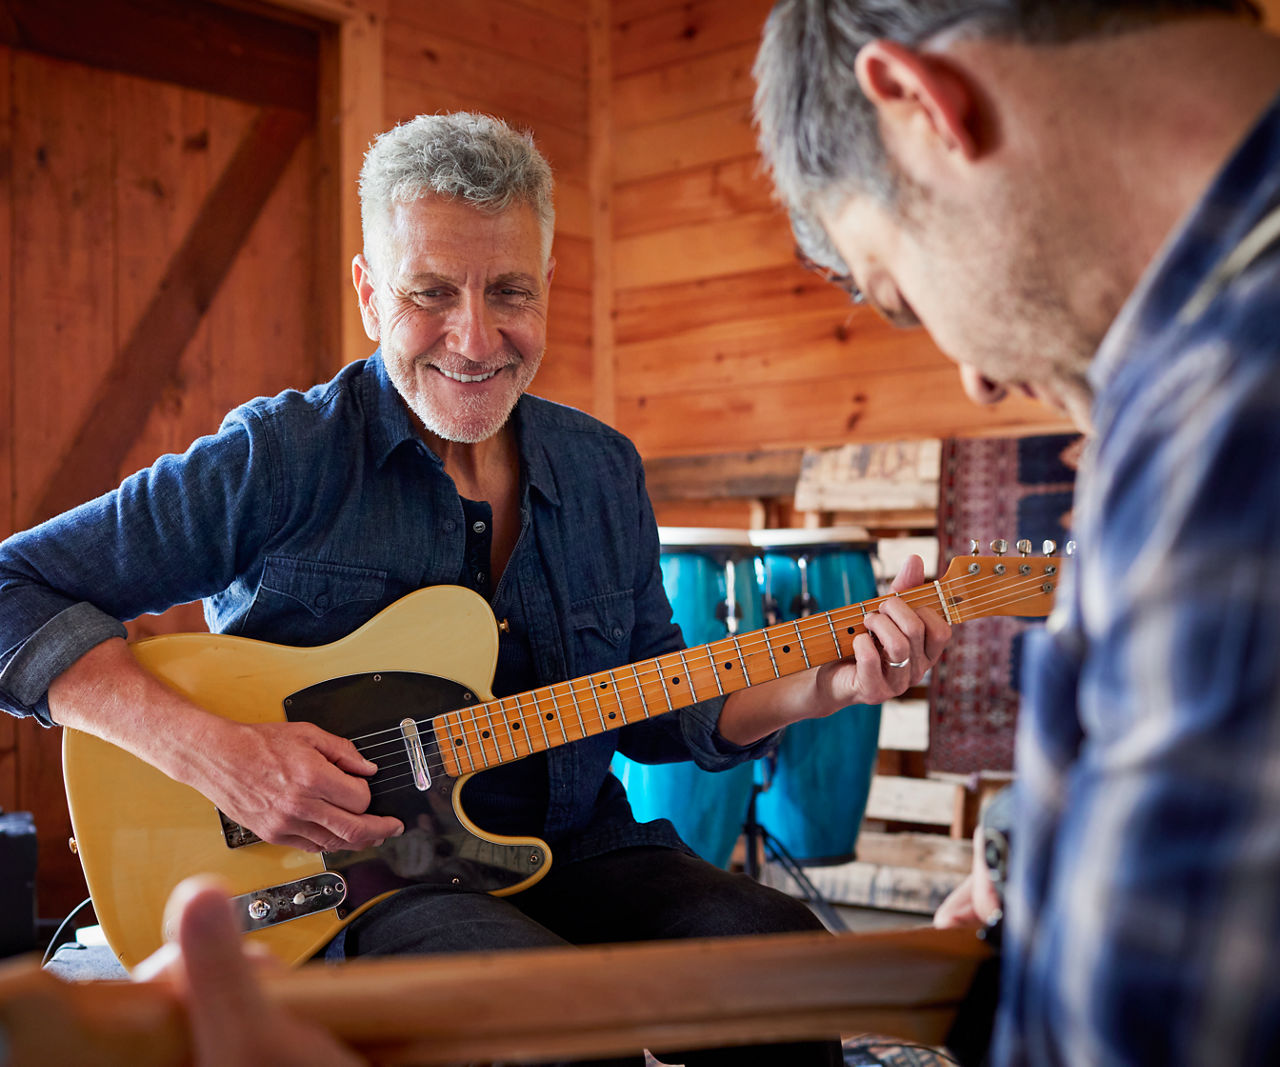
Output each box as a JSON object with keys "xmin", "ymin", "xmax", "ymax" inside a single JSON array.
[{"xmin": 434, "ymin": 557, "xmax": 1062, "ymax": 775}]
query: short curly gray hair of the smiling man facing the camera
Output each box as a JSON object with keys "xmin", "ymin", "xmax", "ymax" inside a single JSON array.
[{"xmin": 360, "ymin": 111, "xmax": 556, "ymax": 261}]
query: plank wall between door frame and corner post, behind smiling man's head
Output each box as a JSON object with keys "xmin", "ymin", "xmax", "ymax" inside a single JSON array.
[{"xmin": 378, "ymin": 0, "xmax": 593, "ymax": 409}]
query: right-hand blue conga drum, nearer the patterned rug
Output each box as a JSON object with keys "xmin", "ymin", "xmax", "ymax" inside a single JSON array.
[{"xmin": 751, "ymin": 527, "xmax": 881, "ymax": 865}]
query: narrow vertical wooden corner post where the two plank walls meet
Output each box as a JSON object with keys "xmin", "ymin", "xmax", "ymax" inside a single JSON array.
[{"xmin": 586, "ymin": 0, "xmax": 618, "ymax": 425}]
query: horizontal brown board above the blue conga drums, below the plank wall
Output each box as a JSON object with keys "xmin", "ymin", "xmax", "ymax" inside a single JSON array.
[{"xmin": 644, "ymin": 448, "xmax": 804, "ymax": 500}]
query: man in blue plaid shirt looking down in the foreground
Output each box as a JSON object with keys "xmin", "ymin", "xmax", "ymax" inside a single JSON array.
[{"xmin": 755, "ymin": 0, "xmax": 1280, "ymax": 1067}]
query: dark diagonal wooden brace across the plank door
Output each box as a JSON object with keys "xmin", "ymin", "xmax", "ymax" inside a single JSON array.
[{"xmin": 29, "ymin": 109, "xmax": 310, "ymax": 525}]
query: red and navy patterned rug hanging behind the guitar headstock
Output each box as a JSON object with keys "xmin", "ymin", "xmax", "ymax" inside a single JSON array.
[{"xmin": 925, "ymin": 434, "xmax": 1083, "ymax": 774}]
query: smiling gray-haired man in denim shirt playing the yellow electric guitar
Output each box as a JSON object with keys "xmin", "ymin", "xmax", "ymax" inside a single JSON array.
[{"xmin": 0, "ymin": 114, "xmax": 950, "ymax": 1067}]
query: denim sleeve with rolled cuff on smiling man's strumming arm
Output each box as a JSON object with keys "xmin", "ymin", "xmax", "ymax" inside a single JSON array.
[{"xmin": 0, "ymin": 417, "xmax": 271, "ymax": 724}]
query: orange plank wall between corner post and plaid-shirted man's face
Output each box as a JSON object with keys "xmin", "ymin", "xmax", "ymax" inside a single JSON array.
[{"xmin": 612, "ymin": 0, "xmax": 1062, "ymax": 458}]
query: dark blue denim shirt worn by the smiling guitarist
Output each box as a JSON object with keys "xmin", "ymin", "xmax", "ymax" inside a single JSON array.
[{"xmin": 0, "ymin": 353, "xmax": 767, "ymax": 860}]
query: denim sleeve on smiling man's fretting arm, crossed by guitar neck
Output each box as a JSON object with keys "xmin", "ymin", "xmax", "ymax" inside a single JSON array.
[{"xmin": 618, "ymin": 458, "xmax": 777, "ymax": 770}]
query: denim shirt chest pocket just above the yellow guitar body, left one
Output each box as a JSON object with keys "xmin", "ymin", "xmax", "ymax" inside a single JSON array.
[{"xmin": 250, "ymin": 555, "xmax": 387, "ymax": 644}]
